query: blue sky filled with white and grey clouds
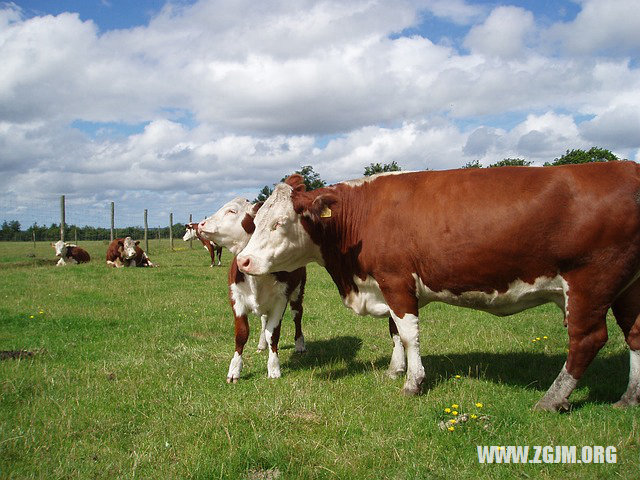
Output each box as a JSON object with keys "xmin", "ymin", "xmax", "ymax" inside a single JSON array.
[{"xmin": 0, "ymin": 0, "xmax": 640, "ymax": 227}]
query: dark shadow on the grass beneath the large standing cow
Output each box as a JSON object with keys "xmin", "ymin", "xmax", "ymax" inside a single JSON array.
[{"xmin": 284, "ymin": 336, "xmax": 629, "ymax": 409}]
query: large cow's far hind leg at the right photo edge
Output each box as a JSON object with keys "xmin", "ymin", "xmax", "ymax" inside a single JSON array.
[{"xmin": 612, "ymin": 280, "xmax": 640, "ymax": 408}]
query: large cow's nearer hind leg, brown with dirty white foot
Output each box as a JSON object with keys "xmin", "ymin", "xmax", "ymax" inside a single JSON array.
[{"xmin": 534, "ymin": 286, "xmax": 608, "ymax": 411}]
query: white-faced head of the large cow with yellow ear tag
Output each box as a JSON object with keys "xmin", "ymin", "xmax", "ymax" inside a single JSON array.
[{"xmin": 237, "ymin": 174, "xmax": 328, "ymax": 275}]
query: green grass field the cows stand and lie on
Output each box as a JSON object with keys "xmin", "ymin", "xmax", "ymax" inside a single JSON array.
[{"xmin": 0, "ymin": 240, "xmax": 640, "ymax": 480}]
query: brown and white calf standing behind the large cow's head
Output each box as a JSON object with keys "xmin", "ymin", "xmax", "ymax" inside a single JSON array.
[{"xmin": 198, "ymin": 197, "xmax": 307, "ymax": 382}]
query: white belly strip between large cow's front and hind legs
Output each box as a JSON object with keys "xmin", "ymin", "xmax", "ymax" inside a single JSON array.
[{"xmin": 413, "ymin": 274, "xmax": 568, "ymax": 316}]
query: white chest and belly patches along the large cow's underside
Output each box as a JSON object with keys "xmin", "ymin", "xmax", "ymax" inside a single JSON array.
[{"xmin": 342, "ymin": 273, "xmax": 568, "ymax": 317}]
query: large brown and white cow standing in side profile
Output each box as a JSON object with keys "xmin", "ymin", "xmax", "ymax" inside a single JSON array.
[{"xmin": 237, "ymin": 161, "xmax": 640, "ymax": 410}]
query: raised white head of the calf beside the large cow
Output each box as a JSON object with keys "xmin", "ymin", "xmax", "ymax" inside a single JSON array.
[{"xmin": 198, "ymin": 197, "xmax": 262, "ymax": 255}]
